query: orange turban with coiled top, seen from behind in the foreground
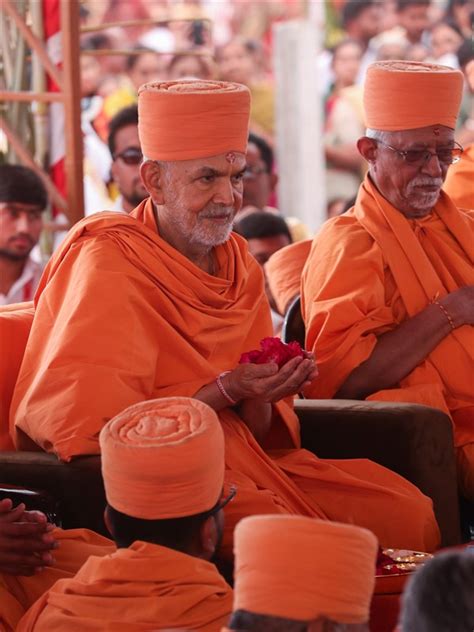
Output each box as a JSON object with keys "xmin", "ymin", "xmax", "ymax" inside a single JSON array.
[{"xmin": 100, "ymin": 397, "xmax": 224, "ymax": 520}]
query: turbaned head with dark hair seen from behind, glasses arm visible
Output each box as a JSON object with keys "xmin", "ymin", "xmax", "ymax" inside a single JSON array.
[{"xmin": 100, "ymin": 397, "xmax": 229, "ymax": 559}]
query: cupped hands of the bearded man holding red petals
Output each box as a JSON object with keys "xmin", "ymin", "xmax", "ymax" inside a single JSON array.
[{"xmin": 222, "ymin": 353, "xmax": 317, "ymax": 402}]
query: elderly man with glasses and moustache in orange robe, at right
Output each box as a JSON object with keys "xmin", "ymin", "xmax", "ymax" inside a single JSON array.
[{"xmin": 302, "ymin": 61, "xmax": 474, "ymax": 499}]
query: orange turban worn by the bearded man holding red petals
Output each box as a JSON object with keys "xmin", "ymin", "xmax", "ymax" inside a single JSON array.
[{"xmin": 138, "ymin": 81, "xmax": 250, "ymax": 161}]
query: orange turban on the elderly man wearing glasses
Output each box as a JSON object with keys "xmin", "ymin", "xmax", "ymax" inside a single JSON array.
[{"xmin": 364, "ymin": 61, "xmax": 464, "ymax": 132}]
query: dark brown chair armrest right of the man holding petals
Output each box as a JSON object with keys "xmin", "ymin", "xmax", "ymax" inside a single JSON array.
[{"xmin": 295, "ymin": 400, "xmax": 461, "ymax": 546}]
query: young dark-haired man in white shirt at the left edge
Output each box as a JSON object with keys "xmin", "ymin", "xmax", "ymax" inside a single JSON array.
[{"xmin": 0, "ymin": 165, "xmax": 48, "ymax": 305}]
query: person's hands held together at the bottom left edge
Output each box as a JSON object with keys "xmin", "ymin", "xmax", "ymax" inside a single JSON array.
[{"xmin": 0, "ymin": 498, "xmax": 58, "ymax": 575}]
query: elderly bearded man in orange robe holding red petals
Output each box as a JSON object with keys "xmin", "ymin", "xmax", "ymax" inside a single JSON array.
[{"xmin": 12, "ymin": 81, "xmax": 439, "ymax": 558}]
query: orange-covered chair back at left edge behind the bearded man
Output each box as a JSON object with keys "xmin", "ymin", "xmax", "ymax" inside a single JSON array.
[{"xmin": 0, "ymin": 301, "xmax": 34, "ymax": 450}]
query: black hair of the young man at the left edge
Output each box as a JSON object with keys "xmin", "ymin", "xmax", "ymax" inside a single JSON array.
[{"xmin": 0, "ymin": 164, "xmax": 48, "ymax": 211}]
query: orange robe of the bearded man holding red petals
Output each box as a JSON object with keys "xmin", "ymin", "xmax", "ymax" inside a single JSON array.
[{"xmin": 12, "ymin": 200, "xmax": 439, "ymax": 558}]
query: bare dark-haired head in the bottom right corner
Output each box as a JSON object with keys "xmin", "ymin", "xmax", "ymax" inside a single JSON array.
[{"xmin": 400, "ymin": 548, "xmax": 474, "ymax": 632}]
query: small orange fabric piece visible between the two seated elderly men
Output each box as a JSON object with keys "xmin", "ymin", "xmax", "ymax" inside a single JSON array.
[{"xmin": 265, "ymin": 239, "xmax": 313, "ymax": 316}]
